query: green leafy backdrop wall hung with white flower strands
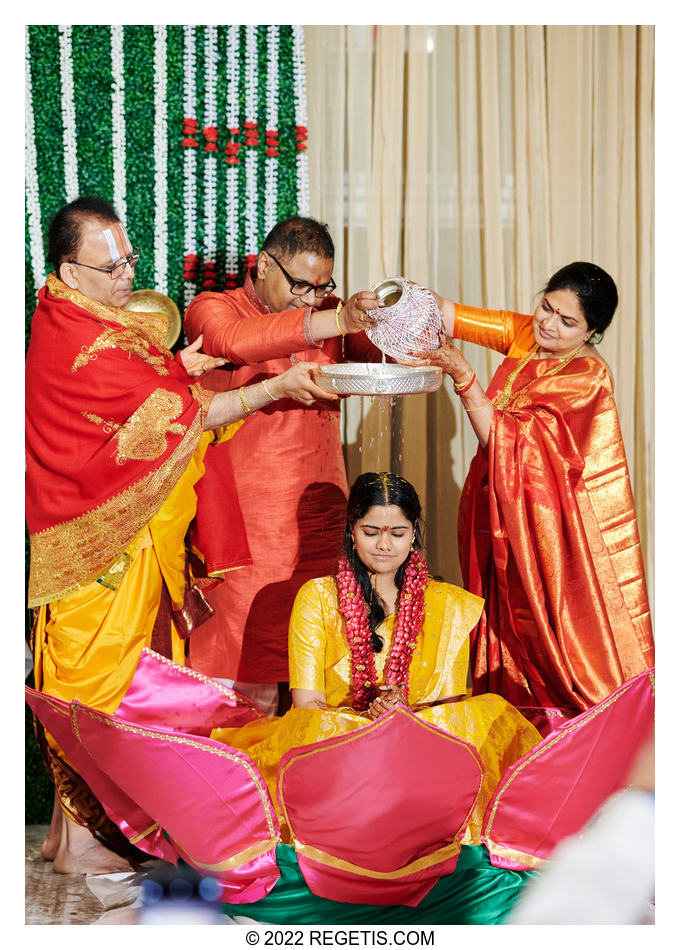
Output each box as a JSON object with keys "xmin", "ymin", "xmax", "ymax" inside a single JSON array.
[{"xmin": 25, "ymin": 25, "xmax": 309, "ymax": 824}]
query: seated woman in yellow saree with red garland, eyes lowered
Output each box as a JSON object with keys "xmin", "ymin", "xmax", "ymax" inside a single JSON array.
[{"xmin": 211, "ymin": 472, "xmax": 541, "ymax": 844}]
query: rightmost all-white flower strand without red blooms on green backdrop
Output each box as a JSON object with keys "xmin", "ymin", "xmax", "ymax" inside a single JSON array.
[{"xmin": 153, "ymin": 26, "xmax": 168, "ymax": 294}]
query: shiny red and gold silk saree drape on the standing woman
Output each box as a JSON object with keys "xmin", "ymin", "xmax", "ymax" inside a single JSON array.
[{"xmin": 458, "ymin": 356, "xmax": 654, "ymax": 717}]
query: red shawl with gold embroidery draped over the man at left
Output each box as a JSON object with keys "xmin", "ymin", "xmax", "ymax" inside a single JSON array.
[{"xmin": 26, "ymin": 274, "xmax": 213, "ymax": 606}]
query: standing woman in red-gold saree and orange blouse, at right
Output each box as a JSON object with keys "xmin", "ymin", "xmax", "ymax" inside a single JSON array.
[{"xmin": 417, "ymin": 262, "xmax": 654, "ymax": 732}]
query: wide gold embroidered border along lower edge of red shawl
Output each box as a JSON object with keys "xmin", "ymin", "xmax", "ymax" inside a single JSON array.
[{"xmin": 28, "ymin": 414, "xmax": 202, "ymax": 607}]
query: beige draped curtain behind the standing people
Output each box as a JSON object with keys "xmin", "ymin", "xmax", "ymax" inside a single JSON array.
[{"xmin": 305, "ymin": 26, "xmax": 654, "ymax": 608}]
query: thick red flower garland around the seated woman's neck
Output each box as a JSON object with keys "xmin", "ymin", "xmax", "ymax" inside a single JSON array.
[{"xmin": 336, "ymin": 551, "xmax": 427, "ymax": 710}]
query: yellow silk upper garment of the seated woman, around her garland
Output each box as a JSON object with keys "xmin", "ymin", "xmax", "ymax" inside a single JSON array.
[{"xmin": 288, "ymin": 577, "xmax": 484, "ymax": 706}]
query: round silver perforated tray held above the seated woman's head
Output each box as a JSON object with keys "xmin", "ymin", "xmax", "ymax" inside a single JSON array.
[{"xmin": 314, "ymin": 363, "xmax": 442, "ymax": 396}]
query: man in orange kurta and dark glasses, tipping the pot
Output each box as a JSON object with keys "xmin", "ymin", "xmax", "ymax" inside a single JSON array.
[{"xmin": 185, "ymin": 218, "xmax": 382, "ymax": 714}]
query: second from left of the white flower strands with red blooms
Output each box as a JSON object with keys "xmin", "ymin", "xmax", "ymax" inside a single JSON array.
[{"xmin": 203, "ymin": 26, "xmax": 217, "ymax": 290}]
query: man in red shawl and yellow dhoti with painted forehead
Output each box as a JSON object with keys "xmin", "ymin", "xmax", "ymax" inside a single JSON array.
[{"xmin": 26, "ymin": 197, "xmax": 364, "ymax": 873}]
